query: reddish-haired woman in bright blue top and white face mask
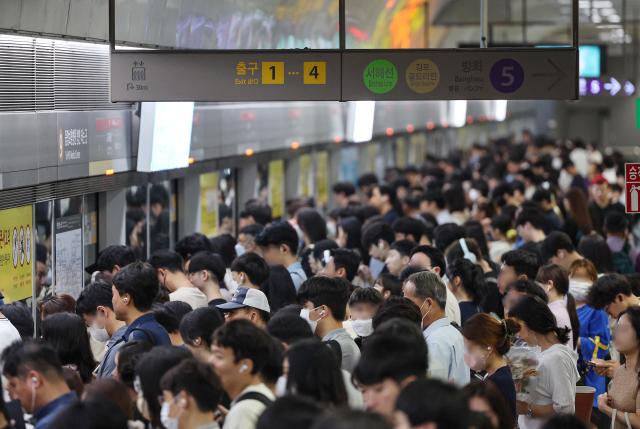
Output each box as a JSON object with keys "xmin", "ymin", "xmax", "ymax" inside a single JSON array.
[{"xmin": 569, "ymin": 259, "xmax": 611, "ymax": 407}]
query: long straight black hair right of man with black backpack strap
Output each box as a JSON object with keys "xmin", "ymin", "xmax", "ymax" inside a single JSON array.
[{"xmin": 287, "ymin": 338, "xmax": 347, "ymax": 408}]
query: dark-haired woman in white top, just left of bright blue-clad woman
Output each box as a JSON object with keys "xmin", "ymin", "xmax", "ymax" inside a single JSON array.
[{"xmin": 536, "ymin": 264, "xmax": 580, "ymax": 350}]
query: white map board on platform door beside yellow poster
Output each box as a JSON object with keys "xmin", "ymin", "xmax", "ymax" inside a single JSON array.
[{"xmin": 55, "ymin": 215, "xmax": 84, "ymax": 298}]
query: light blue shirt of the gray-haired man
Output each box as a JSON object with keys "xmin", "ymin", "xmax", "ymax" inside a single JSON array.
[{"xmin": 423, "ymin": 317, "xmax": 471, "ymax": 387}]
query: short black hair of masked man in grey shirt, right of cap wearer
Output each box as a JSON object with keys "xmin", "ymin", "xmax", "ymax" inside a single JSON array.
[{"xmin": 298, "ymin": 276, "xmax": 351, "ymax": 321}]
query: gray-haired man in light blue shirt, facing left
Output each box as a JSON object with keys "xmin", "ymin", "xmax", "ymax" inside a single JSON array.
[{"xmin": 402, "ymin": 271, "xmax": 470, "ymax": 387}]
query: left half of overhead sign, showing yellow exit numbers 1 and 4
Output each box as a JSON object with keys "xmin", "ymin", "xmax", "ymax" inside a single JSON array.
[{"xmin": 111, "ymin": 51, "xmax": 340, "ymax": 101}]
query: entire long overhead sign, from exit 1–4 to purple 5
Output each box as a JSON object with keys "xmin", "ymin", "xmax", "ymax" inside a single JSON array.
[{"xmin": 111, "ymin": 48, "xmax": 578, "ymax": 102}]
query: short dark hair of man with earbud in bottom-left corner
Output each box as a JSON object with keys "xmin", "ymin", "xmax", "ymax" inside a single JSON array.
[{"xmin": 0, "ymin": 340, "xmax": 64, "ymax": 380}]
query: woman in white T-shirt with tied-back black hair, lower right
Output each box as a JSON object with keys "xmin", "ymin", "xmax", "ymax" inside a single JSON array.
[{"xmin": 509, "ymin": 296, "xmax": 580, "ymax": 429}]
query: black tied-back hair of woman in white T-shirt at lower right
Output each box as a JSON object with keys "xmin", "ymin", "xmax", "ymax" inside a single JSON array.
[{"xmin": 509, "ymin": 296, "xmax": 571, "ymax": 344}]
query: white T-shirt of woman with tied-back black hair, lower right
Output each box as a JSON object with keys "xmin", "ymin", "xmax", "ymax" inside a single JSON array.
[{"xmin": 518, "ymin": 344, "xmax": 580, "ymax": 429}]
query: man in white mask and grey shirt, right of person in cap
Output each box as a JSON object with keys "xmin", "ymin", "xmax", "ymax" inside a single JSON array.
[{"xmin": 298, "ymin": 277, "xmax": 360, "ymax": 372}]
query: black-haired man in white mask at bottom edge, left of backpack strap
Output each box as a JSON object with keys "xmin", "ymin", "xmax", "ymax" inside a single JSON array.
[{"xmin": 160, "ymin": 359, "xmax": 223, "ymax": 429}]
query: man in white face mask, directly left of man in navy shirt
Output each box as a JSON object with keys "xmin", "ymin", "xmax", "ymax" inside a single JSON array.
[{"xmin": 76, "ymin": 281, "xmax": 127, "ymax": 378}]
